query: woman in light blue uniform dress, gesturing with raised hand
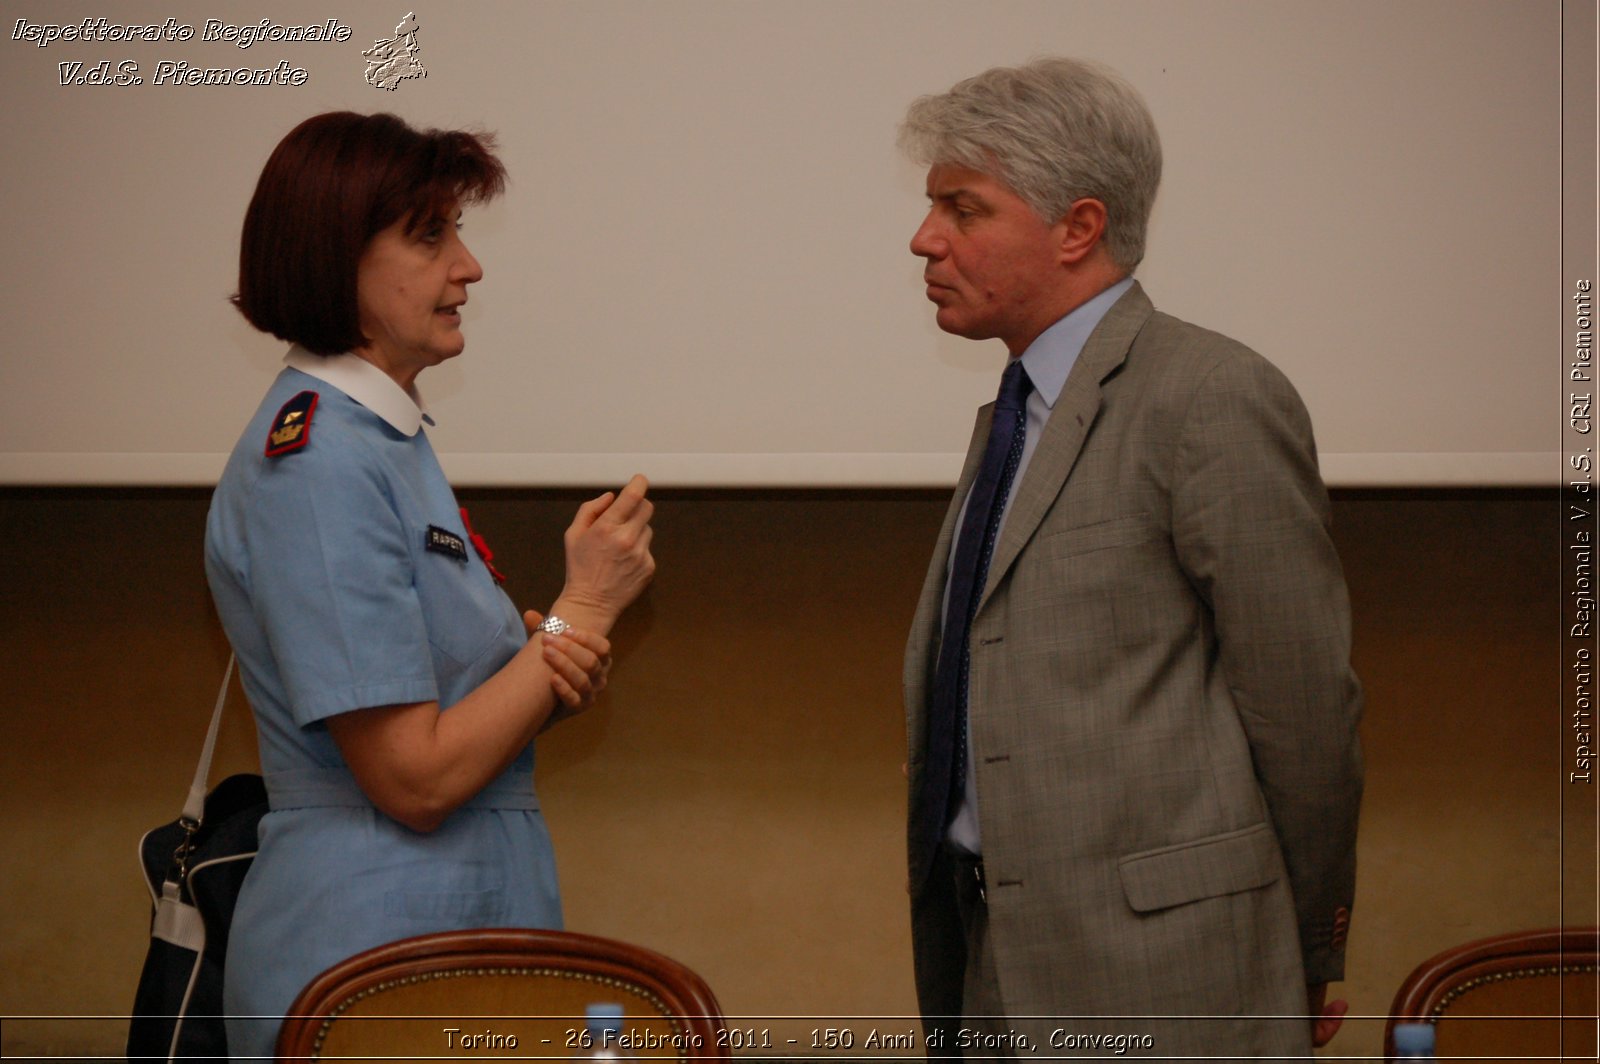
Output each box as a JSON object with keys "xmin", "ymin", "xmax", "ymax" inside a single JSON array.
[{"xmin": 206, "ymin": 112, "xmax": 654, "ymax": 1056}]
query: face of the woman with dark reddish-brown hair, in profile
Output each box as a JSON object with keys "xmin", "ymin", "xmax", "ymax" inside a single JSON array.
[{"xmin": 355, "ymin": 205, "xmax": 483, "ymax": 386}]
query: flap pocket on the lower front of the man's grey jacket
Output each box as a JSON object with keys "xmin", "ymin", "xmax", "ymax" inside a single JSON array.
[{"xmin": 1117, "ymin": 824, "xmax": 1280, "ymax": 912}]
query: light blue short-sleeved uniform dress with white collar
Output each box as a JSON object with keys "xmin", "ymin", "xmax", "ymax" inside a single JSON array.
[{"xmin": 205, "ymin": 349, "xmax": 562, "ymax": 1058}]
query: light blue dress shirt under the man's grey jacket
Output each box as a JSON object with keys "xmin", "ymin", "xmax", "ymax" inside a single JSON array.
[{"xmin": 939, "ymin": 277, "xmax": 1133, "ymax": 854}]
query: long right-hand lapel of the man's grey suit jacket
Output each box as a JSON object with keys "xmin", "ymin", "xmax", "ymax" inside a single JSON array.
[{"xmin": 978, "ymin": 282, "xmax": 1155, "ymax": 610}]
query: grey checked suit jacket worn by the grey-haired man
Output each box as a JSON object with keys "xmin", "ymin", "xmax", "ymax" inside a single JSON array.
[{"xmin": 904, "ymin": 285, "xmax": 1362, "ymax": 1056}]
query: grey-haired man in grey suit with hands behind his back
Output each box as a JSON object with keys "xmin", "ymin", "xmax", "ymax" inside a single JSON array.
[{"xmin": 901, "ymin": 59, "xmax": 1362, "ymax": 1058}]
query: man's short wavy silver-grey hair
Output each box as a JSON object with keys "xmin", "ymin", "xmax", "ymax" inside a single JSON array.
[{"xmin": 899, "ymin": 59, "xmax": 1162, "ymax": 272}]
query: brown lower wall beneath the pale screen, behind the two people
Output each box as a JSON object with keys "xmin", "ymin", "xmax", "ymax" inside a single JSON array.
[{"xmin": 0, "ymin": 490, "xmax": 1592, "ymax": 1056}]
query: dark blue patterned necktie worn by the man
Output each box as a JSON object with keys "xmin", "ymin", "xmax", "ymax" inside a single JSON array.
[{"xmin": 914, "ymin": 358, "xmax": 1032, "ymax": 886}]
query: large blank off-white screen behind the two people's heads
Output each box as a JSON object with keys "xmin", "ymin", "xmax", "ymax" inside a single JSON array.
[{"xmin": 0, "ymin": 0, "xmax": 1563, "ymax": 485}]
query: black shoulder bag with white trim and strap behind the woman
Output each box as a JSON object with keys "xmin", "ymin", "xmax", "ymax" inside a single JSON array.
[{"xmin": 128, "ymin": 662, "xmax": 267, "ymax": 1061}]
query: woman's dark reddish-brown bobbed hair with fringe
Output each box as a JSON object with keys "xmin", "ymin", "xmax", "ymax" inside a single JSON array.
[{"xmin": 232, "ymin": 110, "xmax": 506, "ymax": 355}]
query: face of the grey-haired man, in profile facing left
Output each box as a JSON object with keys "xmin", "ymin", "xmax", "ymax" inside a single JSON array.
[{"xmin": 910, "ymin": 163, "xmax": 1059, "ymax": 354}]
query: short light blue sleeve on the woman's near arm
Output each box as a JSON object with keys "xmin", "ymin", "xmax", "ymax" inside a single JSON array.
[{"xmin": 245, "ymin": 426, "xmax": 438, "ymax": 726}]
